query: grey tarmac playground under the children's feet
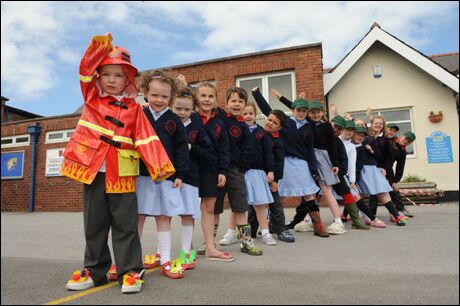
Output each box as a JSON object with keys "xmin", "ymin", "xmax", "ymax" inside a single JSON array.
[{"xmin": 1, "ymin": 203, "xmax": 459, "ymax": 305}]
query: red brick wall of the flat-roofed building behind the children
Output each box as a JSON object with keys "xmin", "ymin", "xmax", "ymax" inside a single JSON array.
[{"xmin": 1, "ymin": 45, "xmax": 325, "ymax": 211}]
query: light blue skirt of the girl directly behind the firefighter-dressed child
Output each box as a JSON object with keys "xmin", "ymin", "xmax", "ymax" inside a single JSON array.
[{"xmin": 136, "ymin": 176, "xmax": 186, "ymax": 217}]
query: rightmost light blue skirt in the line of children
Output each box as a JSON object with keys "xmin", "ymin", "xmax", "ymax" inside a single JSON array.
[{"xmin": 357, "ymin": 165, "xmax": 393, "ymax": 195}]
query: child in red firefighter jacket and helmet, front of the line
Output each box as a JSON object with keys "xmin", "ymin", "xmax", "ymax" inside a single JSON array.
[{"xmin": 61, "ymin": 33, "xmax": 175, "ymax": 293}]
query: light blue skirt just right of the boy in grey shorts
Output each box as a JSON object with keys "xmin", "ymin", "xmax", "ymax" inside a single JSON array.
[{"xmin": 244, "ymin": 169, "xmax": 274, "ymax": 205}]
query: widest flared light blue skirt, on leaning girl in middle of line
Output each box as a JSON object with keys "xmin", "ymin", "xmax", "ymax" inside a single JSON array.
[{"xmin": 278, "ymin": 156, "xmax": 319, "ymax": 197}]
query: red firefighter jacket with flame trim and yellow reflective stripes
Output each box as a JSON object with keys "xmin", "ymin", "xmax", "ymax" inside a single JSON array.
[{"xmin": 60, "ymin": 36, "xmax": 175, "ymax": 193}]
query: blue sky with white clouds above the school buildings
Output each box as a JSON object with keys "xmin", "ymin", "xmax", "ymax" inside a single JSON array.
[{"xmin": 1, "ymin": 1, "xmax": 459, "ymax": 116}]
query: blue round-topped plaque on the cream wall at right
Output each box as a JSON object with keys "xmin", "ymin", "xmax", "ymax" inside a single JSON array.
[{"xmin": 426, "ymin": 131, "xmax": 454, "ymax": 164}]
